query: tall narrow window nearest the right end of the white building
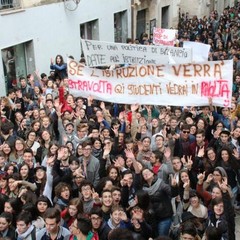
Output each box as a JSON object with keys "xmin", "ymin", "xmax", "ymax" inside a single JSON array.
[{"xmin": 114, "ymin": 11, "xmax": 127, "ymax": 43}]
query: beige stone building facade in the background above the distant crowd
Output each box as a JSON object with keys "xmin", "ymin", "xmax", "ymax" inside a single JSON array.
[{"xmin": 132, "ymin": 0, "xmax": 235, "ymax": 38}]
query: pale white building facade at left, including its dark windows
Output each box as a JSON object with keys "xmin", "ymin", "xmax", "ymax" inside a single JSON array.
[{"xmin": 0, "ymin": 0, "xmax": 131, "ymax": 96}]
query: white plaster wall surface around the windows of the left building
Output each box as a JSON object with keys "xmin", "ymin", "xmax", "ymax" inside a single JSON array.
[{"xmin": 0, "ymin": 0, "xmax": 131, "ymax": 96}]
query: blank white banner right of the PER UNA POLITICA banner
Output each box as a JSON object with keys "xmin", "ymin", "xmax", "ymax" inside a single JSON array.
[{"xmin": 183, "ymin": 41, "xmax": 211, "ymax": 62}]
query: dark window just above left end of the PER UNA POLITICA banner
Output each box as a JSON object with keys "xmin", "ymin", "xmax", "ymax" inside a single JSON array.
[{"xmin": 80, "ymin": 20, "xmax": 99, "ymax": 40}]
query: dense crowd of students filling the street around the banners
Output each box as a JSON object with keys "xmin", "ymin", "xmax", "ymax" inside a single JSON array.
[{"xmin": 0, "ymin": 1, "xmax": 240, "ymax": 240}]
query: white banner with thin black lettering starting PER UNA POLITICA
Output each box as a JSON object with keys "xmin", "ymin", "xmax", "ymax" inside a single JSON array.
[{"xmin": 81, "ymin": 39, "xmax": 192, "ymax": 67}]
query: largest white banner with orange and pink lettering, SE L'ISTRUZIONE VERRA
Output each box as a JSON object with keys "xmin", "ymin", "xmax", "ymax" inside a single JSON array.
[{"xmin": 68, "ymin": 59, "xmax": 233, "ymax": 107}]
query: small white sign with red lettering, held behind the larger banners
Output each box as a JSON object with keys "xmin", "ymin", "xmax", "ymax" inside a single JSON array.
[{"xmin": 153, "ymin": 28, "xmax": 178, "ymax": 46}]
